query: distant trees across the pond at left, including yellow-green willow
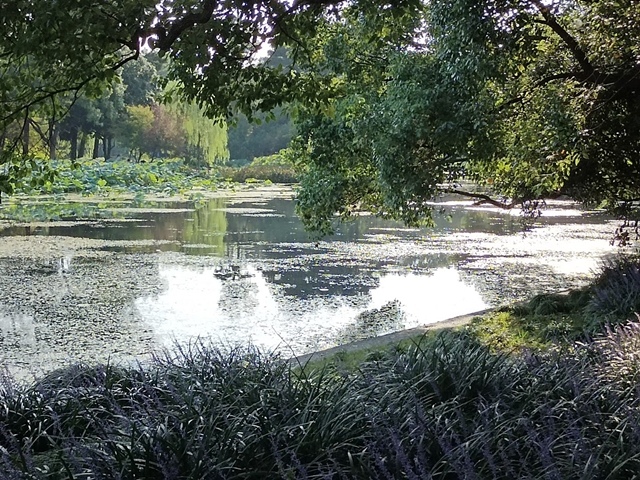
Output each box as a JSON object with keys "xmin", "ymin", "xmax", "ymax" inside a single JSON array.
[{"xmin": 0, "ymin": 54, "xmax": 228, "ymax": 167}]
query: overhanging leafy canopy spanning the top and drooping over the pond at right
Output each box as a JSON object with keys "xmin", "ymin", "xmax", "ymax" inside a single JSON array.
[{"xmin": 0, "ymin": 0, "xmax": 640, "ymax": 231}]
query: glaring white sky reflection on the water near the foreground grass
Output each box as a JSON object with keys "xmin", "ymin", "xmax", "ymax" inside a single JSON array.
[{"xmin": 135, "ymin": 265, "xmax": 487, "ymax": 353}]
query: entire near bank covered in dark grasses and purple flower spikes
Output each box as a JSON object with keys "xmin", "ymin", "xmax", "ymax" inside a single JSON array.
[{"xmin": 0, "ymin": 253, "xmax": 640, "ymax": 479}]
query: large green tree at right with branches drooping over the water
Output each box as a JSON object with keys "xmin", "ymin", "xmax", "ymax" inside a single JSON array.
[{"xmin": 294, "ymin": 0, "xmax": 640, "ymax": 231}]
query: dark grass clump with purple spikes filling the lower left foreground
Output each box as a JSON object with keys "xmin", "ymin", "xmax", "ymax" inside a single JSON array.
[{"xmin": 0, "ymin": 343, "xmax": 365, "ymax": 479}]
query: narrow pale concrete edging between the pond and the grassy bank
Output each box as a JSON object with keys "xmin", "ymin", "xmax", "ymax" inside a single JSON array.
[{"xmin": 290, "ymin": 308, "xmax": 495, "ymax": 365}]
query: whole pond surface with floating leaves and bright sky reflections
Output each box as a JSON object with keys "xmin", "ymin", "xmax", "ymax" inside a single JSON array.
[{"xmin": 0, "ymin": 187, "xmax": 615, "ymax": 377}]
